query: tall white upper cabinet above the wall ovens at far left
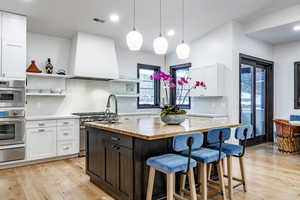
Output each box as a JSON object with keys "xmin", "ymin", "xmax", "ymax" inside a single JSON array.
[{"xmin": 1, "ymin": 12, "xmax": 26, "ymax": 79}]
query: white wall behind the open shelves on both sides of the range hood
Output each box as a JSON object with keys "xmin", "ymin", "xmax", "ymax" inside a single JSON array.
[{"xmin": 27, "ymin": 33, "xmax": 164, "ymax": 116}]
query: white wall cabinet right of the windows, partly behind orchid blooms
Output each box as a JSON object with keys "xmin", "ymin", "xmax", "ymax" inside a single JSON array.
[{"xmin": 190, "ymin": 64, "xmax": 225, "ymax": 97}]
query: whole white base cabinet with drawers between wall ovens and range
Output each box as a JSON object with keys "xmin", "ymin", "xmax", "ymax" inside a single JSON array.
[{"xmin": 26, "ymin": 119, "xmax": 79, "ymax": 160}]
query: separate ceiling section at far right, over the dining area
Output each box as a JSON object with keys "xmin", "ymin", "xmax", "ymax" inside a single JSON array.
[{"xmin": 249, "ymin": 21, "xmax": 300, "ymax": 44}]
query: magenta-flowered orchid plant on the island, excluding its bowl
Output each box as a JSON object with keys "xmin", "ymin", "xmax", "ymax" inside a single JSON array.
[{"xmin": 150, "ymin": 72, "xmax": 206, "ymax": 115}]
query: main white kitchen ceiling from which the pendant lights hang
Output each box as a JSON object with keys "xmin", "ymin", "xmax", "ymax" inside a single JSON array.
[{"xmin": 0, "ymin": 0, "xmax": 299, "ymax": 51}]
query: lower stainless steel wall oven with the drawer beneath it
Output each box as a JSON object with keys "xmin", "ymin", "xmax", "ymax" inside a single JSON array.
[{"xmin": 0, "ymin": 108, "xmax": 25, "ymax": 162}]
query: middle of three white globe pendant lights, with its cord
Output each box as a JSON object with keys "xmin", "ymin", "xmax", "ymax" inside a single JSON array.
[{"xmin": 153, "ymin": 0, "xmax": 168, "ymax": 55}]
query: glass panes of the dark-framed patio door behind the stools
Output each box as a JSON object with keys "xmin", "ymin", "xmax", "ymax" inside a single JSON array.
[{"xmin": 240, "ymin": 62, "xmax": 266, "ymax": 141}]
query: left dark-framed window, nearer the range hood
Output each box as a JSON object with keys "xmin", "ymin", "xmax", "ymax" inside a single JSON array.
[{"xmin": 137, "ymin": 64, "xmax": 160, "ymax": 108}]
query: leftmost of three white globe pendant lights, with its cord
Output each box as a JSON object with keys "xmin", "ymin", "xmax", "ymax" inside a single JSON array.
[{"xmin": 126, "ymin": 0, "xmax": 143, "ymax": 51}]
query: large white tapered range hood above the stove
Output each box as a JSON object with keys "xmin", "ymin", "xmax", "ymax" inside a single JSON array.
[{"xmin": 71, "ymin": 33, "xmax": 119, "ymax": 79}]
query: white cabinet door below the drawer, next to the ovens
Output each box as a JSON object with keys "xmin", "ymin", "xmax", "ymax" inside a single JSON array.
[{"xmin": 26, "ymin": 127, "xmax": 56, "ymax": 160}]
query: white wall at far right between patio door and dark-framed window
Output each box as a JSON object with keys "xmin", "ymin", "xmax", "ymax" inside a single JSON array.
[{"xmin": 274, "ymin": 41, "xmax": 300, "ymax": 119}]
